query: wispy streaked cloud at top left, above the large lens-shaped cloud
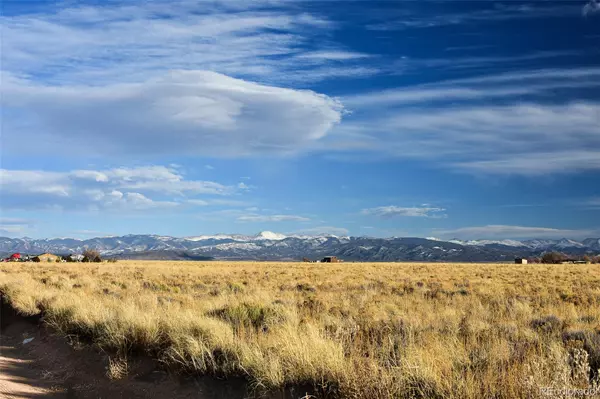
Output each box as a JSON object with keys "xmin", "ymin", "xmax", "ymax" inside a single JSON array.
[{"xmin": 1, "ymin": 0, "xmax": 370, "ymax": 85}]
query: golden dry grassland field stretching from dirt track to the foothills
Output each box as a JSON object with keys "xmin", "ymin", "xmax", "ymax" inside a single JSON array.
[{"xmin": 0, "ymin": 261, "xmax": 600, "ymax": 398}]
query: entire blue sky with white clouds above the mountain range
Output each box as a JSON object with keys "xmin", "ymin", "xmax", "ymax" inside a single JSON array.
[{"xmin": 0, "ymin": 0, "xmax": 600, "ymax": 239}]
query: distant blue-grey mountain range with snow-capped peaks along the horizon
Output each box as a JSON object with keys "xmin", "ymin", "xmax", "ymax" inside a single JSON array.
[{"xmin": 0, "ymin": 231, "xmax": 600, "ymax": 262}]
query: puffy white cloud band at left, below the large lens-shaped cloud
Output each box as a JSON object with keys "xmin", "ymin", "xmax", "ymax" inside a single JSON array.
[{"xmin": 0, "ymin": 166, "xmax": 237, "ymax": 210}]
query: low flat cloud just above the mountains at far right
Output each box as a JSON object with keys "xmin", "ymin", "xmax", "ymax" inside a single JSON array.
[{"xmin": 433, "ymin": 225, "xmax": 597, "ymax": 239}]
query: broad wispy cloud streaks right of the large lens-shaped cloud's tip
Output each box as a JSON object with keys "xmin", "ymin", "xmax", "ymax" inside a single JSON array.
[{"xmin": 328, "ymin": 68, "xmax": 600, "ymax": 176}]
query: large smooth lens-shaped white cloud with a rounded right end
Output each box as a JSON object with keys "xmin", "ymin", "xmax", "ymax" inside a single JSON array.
[{"xmin": 1, "ymin": 71, "xmax": 342, "ymax": 157}]
